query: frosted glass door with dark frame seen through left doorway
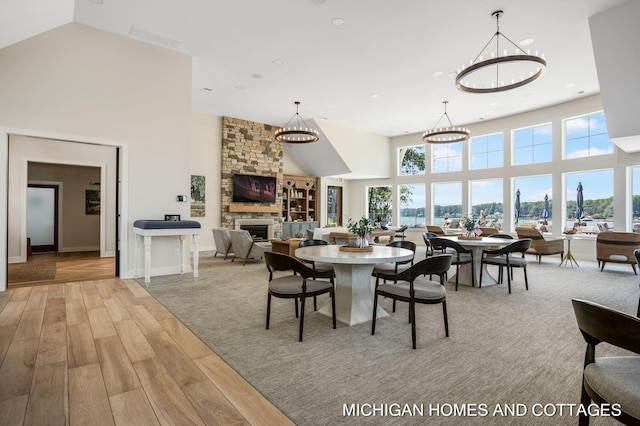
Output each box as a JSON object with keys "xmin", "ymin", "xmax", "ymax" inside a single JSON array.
[{"xmin": 27, "ymin": 185, "xmax": 58, "ymax": 252}]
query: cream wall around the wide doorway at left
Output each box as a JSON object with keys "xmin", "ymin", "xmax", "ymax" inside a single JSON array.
[{"xmin": 0, "ymin": 23, "xmax": 192, "ymax": 290}]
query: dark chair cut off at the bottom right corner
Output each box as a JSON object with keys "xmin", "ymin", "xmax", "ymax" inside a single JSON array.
[{"xmin": 571, "ymin": 299, "xmax": 640, "ymax": 425}]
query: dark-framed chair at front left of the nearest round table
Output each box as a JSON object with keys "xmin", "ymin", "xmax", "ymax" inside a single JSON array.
[{"xmin": 264, "ymin": 251, "xmax": 336, "ymax": 342}]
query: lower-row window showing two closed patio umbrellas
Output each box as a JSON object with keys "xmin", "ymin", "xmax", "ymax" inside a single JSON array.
[{"xmin": 513, "ymin": 175, "xmax": 562, "ymax": 225}]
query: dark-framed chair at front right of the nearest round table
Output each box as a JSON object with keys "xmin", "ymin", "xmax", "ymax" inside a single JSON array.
[{"xmin": 371, "ymin": 255, "xmax": 452, "ymax": 349}]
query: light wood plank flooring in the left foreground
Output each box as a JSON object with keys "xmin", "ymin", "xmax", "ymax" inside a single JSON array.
[{"xmin": 0, "ymin": 278, "xmax": 292, "ymax": 425}]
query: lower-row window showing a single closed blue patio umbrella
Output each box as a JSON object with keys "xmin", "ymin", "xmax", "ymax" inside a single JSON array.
[{"xmin": 566, "ymin": 169, "xmax": 613, "ymax": 228}]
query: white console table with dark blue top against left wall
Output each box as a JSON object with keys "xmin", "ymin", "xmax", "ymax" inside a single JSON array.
[{"xmin": 133, "ymin": 220, "xmax": 200, "ymax": 287}]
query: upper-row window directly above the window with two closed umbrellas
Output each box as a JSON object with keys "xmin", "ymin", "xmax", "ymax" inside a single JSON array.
[{"xmin": 513, "ymin": 123, "xmax": 552, "ymax": 166}]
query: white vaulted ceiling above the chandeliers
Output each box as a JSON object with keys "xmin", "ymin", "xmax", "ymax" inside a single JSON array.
[{"xmin": 0, "ymin": 0, "xmax": 624, "ymax": 136}]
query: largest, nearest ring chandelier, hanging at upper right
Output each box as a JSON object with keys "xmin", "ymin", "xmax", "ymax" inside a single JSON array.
[{"xmin": 456, "ymin": 10, "xmax": 547, "ymax": 93}]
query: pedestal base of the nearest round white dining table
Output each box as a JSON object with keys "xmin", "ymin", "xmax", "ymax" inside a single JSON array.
[{"xmin": 318, "ymin": 263, "xmax": 389, "ymax": 325}]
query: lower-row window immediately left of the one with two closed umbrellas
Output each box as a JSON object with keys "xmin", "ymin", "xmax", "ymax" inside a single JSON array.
[{"xmin": 468, "ymin": 179, "xmax": 504, "ymax": 226}]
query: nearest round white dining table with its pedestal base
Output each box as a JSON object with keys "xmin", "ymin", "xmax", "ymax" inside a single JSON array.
[{"xmin": 295, "ymin": 245, "xmax": 413, "ymax": 325}]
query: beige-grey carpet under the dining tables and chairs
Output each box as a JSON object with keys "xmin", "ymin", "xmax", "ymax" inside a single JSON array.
[{"xmin": 142, "ymin": 252, "xmax": 640, "ymax": 425}]
